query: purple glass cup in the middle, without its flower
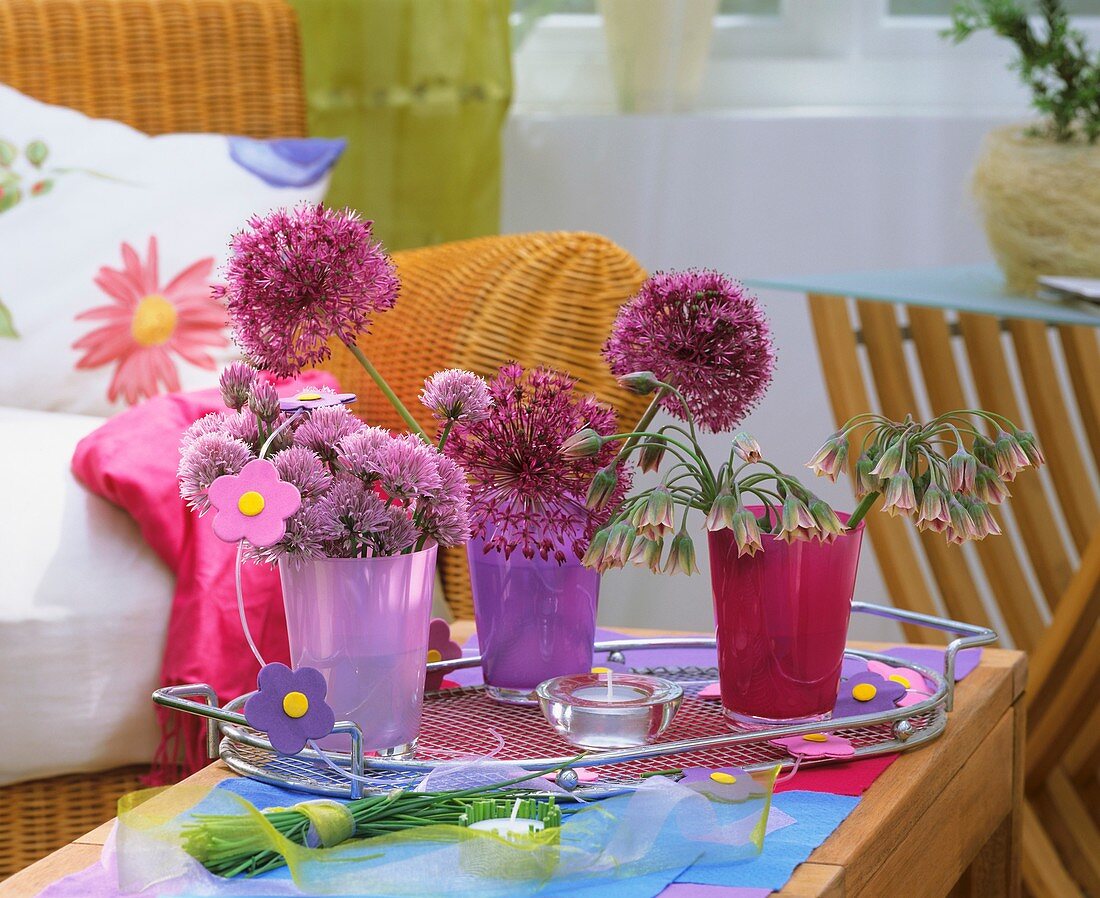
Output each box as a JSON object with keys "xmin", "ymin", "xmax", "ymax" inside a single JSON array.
[{"xmin": 466, "ymin": 538, "xmax": 600, "ymax": 704}]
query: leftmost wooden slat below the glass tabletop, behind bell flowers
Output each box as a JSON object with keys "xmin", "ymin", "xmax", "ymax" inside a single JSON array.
[{"xmin": 809, "ymin": 295, "xmax": 937, "ymax": 640}]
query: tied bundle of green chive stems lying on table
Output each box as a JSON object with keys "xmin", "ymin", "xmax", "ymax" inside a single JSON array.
[{"xmin": 183, "ymin": 758, "xmax": 578, "ymax": 878}]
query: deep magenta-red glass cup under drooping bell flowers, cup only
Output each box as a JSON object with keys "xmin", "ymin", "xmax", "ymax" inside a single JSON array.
[{"xmin": 708, "ymin": 506, "xmax": 864, "ymax": 730}]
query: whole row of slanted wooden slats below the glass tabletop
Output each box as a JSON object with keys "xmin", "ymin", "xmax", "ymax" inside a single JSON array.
[{"xmin": 810, "ymin": 296, "xmax": 1100, "ymax": 649}]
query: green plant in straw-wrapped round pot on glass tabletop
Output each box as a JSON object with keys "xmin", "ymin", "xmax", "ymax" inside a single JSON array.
[{"xmin": 946, "ymin": 0, "xmax": 1100, "ymax": 294}]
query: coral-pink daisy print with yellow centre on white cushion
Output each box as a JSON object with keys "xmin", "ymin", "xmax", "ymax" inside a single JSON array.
[{"xmin": 73, "ymin": 237, "xmax": 229, "ymax": 405}]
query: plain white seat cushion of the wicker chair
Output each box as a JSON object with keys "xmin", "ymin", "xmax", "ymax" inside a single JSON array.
[{"xmin": 0, "ymin": 408, "xmax": 175, "ymax": 785}]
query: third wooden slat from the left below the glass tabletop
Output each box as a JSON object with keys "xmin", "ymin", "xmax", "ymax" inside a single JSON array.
[{"xmin": 909, "ymin": 307, "xmax": 1044, "ymax": 649}]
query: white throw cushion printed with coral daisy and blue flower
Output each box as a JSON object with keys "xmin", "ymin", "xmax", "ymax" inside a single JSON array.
[{"xmin": 0, "ymin": 85, "xmax": 343, "ymax": 415}]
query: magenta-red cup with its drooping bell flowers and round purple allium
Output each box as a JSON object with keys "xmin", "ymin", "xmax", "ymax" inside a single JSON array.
[{"xmin": 562, "ymin": 272, "xmax": 1044, "ymax": 729}]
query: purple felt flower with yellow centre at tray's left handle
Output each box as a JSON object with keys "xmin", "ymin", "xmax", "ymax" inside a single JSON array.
[{"xmin": 244, "ymin": 661, "xmax": 337, "ymax": 755}]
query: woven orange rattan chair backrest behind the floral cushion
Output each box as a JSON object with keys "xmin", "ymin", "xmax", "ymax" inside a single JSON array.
[{"xmin": 0, "ymin": 0, "xmax": 306, "ymax": 138}]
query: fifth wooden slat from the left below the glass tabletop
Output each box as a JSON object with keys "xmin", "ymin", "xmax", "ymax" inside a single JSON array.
[{"xmin": 1009, "ymin": 318, "xmax": 1100, "ymax": 550}]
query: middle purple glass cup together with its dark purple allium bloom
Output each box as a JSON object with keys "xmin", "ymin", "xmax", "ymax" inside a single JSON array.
[{"xmin": 437, "ymin": 363, "xmax": 630, "ymax": 704}]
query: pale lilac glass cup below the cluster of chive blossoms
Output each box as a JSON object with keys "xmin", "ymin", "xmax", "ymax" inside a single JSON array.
[{"xmin": 279, "ymin": 546, "xmax": 436, "ymax": 755}]
